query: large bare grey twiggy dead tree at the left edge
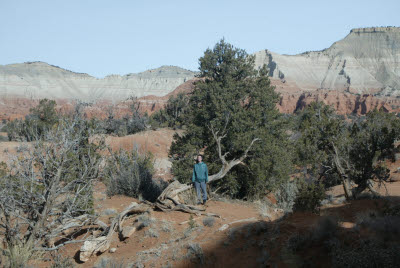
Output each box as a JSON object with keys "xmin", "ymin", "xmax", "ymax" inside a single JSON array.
[{"xmin": 0, "ymin": 118, "xmax": 105, "ymax": 261}]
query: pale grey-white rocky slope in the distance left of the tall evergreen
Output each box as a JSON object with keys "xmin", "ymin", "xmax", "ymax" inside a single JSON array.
[{"xmin": 0, "ymin": 62, "xmax": 195, "ymax": 101}]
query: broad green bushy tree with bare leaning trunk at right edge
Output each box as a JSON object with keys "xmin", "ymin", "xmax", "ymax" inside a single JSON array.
[{"xmin": 295, "ymin": 102, "xmax": 400, "ymax": 199}]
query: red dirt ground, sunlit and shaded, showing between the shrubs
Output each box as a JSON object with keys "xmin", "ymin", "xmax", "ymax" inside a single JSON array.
[{"xmin": 0, "ymin": 129, "xmax": 400, "ymax": 267}]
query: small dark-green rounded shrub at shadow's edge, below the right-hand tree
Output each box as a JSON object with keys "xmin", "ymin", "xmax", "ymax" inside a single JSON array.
[{"xmin": 294, "ymin": 180, "xmax": 325, "ymax": 212}]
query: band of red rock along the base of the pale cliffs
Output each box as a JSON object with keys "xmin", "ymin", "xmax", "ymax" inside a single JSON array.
[{"xmin": 0, "ymin": 79, "xmax": 400, "ymax": 120}]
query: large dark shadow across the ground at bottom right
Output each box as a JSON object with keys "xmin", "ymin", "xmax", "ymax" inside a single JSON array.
[{"xmin": 174, "ymin": 197, "xmax": 400, "ymax": 268}]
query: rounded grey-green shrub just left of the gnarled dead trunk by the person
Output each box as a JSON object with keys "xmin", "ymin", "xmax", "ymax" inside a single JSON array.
[{"xmin": 104, "ymin": 150, "xmax": 167, "ymax": 201}]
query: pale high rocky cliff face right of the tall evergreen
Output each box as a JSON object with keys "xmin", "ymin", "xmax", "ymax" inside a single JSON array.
[{"xmin": 255, "ymin": 27, "xmax": 400, "ymax": 96}]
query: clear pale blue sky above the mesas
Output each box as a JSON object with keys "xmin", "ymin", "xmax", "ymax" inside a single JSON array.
[{"xmin": 0, "ymin": 0, "xmax": 400, "ymax": 78}]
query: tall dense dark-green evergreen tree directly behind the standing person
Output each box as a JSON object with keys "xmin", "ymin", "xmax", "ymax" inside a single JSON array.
[{"xmin": 170, "ymin": 40, "xmax": 291, "ymax": 197}]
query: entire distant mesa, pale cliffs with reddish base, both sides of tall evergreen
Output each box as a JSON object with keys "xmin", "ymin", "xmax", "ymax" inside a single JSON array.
[{"xmin": 0, "ymin": 27, "xmax": 400, "ymax": 117}]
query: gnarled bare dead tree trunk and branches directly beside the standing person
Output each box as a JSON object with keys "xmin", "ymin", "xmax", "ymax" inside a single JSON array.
[{"xmin": 154, "ymin": 117, "xmax": 260, "ymax": 216}]
